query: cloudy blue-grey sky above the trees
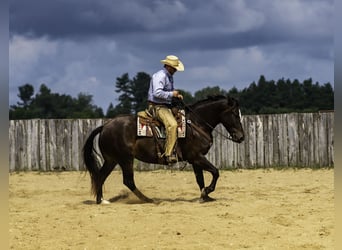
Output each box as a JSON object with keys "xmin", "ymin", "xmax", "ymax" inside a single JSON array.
[{"xmin": 9, "ymin": 0, "xmax": 334, "ymax": 112}]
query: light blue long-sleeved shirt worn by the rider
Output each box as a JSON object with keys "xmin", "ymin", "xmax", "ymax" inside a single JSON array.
[{"xmin": 148, "ymin": 68, "xmax": 174, "ymax": 104}]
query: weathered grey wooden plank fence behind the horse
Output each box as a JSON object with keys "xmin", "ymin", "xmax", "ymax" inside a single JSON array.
[{"xmin": 9, "ymin": 112, "xmax": 334, "ymax": 171}]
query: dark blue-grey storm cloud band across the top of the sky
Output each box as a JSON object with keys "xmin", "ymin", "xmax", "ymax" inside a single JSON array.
[{"xmin": 10, "ymin": 0, "xmax": 332, "ymax": 54}]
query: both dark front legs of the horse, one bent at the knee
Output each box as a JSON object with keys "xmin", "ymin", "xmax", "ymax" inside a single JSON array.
[{"xmin": 193, "ymin": 156, "xmax": 220, "ymax": 202}]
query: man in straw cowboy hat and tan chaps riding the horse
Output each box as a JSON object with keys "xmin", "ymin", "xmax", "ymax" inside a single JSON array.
[{"xmin": 148, "ymin": 55, "xmax": 184, "ymax": 163}]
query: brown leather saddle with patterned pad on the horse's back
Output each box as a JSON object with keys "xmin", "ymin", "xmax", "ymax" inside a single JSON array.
[{"xmin": 137, "ymin": 109, "xmax": 186, "ymax": 138}]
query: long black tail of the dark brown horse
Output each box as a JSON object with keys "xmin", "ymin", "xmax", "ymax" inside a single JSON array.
[{"xmin": 83, "ymin": 125, "xmax": 103, "ymax": 195}]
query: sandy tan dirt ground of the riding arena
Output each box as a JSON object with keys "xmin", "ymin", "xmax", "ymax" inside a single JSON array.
[{"xmin": 9, "ymin": 169, "xmax": 335, "ymax": 250}]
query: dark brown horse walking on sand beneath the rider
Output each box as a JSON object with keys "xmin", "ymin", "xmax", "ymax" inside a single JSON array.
[{"xmin": 83, "ymin": 95, "xmax": 244, "ymax": 204}]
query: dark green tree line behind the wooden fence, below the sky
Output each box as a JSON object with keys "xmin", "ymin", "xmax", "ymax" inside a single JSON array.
[{"xmin": 9, "ymin": 72, "xmax": 334, "ymax": 120}]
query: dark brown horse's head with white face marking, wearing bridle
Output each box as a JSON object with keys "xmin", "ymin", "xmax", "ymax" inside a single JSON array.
[{"xmin": 220, "ymin": 96, "xmax": 245, "ymax": 143}]
